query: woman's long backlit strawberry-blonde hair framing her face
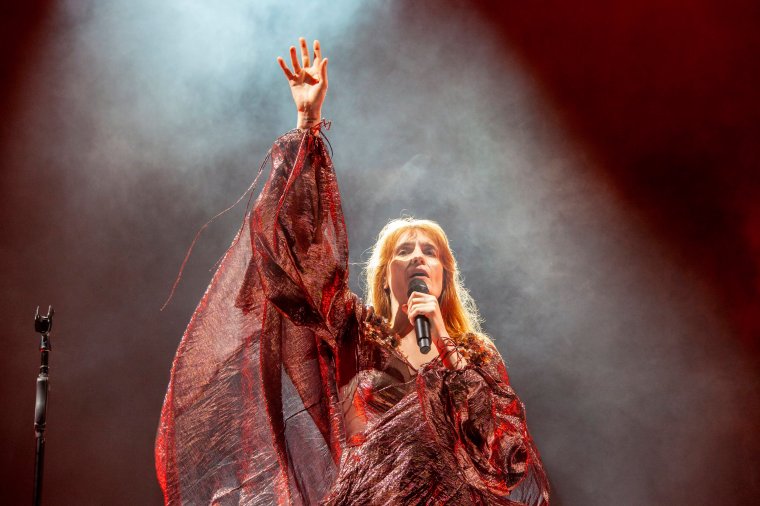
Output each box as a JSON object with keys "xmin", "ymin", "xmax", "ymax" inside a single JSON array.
[{"xmin": 364, "ymin": 216, "xmax": 488, "ymax": 341}]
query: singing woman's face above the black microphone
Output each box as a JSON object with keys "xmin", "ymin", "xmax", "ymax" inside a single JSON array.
[{"xmin": 384, "ymin": 229, "xmax": 443, "ymax": 313}]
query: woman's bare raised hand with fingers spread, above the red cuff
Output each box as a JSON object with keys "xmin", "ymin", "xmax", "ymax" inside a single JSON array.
[{"xmin": 277, "ymin": 37, "xmax": 327, "ymax": 128}]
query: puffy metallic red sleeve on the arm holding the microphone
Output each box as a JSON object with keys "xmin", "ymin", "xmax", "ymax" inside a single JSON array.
[{"xmin": 421, "ymin": 343, "xmax": 549, "ymax": 506}]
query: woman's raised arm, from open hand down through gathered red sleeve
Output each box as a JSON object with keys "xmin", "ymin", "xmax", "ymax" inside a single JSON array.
[{"xmin": 241, "ymin": 39, "xmax": 352, "ymax": 345}]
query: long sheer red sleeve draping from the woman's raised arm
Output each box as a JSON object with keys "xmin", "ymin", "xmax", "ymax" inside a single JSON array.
[{"xmin": 156, "ymin": 130, "xmax": 355, "ymax": 504}]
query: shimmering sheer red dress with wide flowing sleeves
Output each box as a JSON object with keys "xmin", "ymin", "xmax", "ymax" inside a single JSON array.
[{"xmin": 156, "ymin": 130, "xmax": 549, "ymax": 505}]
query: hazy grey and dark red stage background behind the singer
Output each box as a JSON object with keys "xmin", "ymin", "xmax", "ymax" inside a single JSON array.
[{"xmin": 0, "ymin": 0, "xmax": 760, "ymax": 505}]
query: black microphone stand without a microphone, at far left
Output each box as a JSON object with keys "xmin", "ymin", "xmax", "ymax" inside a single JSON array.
[{"xmin": 34, "ymin": 306, "xmax": 53, "ymax": 506}]
